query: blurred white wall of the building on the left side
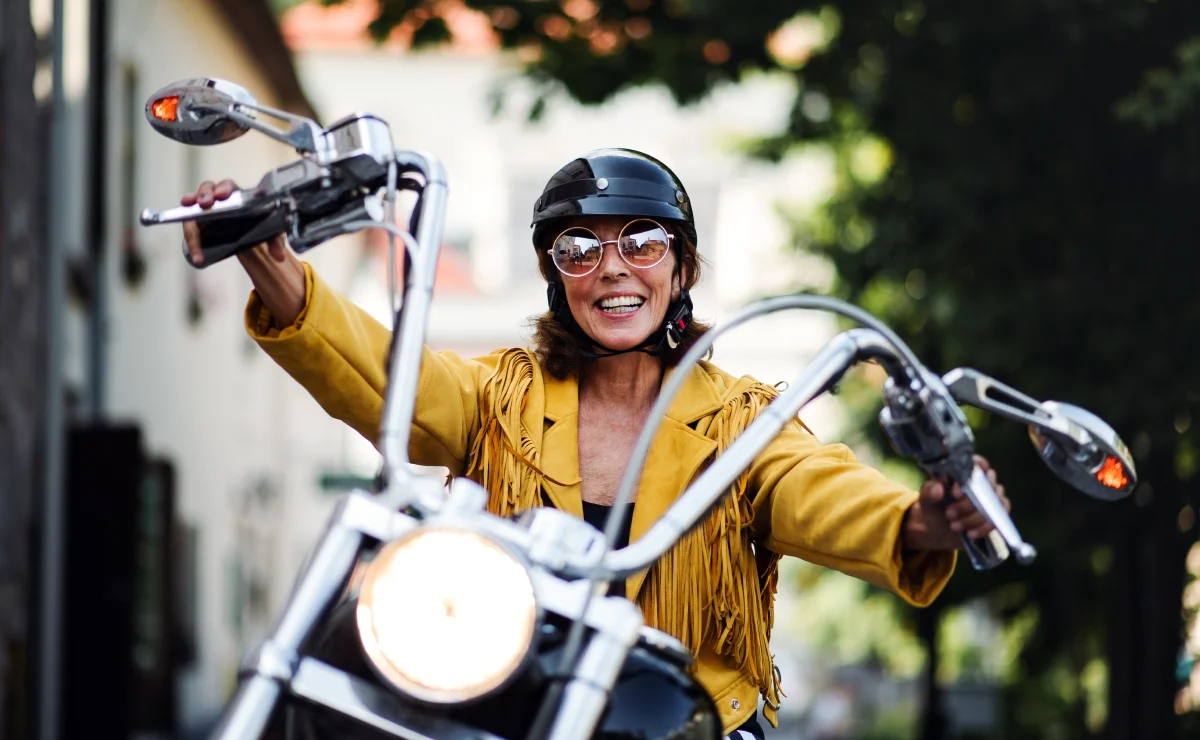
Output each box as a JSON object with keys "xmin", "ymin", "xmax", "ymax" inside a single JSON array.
[{"xmin": 67, "ymin": 0, "xmax": 355, "ymax": 726}]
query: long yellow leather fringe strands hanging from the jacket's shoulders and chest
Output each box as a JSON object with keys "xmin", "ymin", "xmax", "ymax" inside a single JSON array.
[{"xmin": 467, "ymin": 349, "xmax": 782, "ymax": 716}]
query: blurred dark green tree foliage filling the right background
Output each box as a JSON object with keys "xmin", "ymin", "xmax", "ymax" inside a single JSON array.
[{"xmin": 325, "ymin": 0, "xmax": 1200, "ymax": 738}]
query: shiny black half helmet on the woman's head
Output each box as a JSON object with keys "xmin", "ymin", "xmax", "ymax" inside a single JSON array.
[{"xmin": 530, "ymin": 149, "xmax": 696, "ymax": 247}]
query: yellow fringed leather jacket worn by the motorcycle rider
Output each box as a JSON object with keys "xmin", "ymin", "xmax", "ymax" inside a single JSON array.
[{"xmin": 246, "ymin": 264, "xmax": 955, "ymax": 733}]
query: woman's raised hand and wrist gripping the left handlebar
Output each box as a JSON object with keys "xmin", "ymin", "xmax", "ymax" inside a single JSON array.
[{"xmin": 179, "ymin": 180, "xmax": 307, "ymax": 329}]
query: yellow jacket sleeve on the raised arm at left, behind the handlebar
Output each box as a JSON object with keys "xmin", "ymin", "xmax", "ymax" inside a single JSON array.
[{"xmin": 245, "ymin": 263, "xmax": 491, "ymax": 475}]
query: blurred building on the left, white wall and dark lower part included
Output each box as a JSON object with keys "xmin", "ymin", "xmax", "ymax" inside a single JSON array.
[{"xmin": 34, "ymin": 0, "xmax": 343, "ymax": 736}]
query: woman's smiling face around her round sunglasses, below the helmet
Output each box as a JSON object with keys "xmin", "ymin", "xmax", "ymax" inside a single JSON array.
[{"xmin": 559, "ymin": 216, "xmax": 678, "ymax": 350}]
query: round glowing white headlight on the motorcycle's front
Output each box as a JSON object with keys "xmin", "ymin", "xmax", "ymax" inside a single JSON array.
[{"xmin": 358, "ymin": 529, "xmax": 538, "ymax": 704}]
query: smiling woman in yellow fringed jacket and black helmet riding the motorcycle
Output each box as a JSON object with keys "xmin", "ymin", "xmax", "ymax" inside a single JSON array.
[{"xmin": 182, "ymin": 149, "xmax": 1007, "ymax": 738}]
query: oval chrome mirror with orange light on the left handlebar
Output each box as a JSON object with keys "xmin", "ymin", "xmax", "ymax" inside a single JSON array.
[{"xmin": 145, "ymin": 77, "xmax": 258, "ymax": 146}]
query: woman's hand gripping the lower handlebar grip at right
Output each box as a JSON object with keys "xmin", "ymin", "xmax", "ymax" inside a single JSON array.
[{"xmin": 902, "ymin": 455, "xmax": 1013, "ymax": 551}]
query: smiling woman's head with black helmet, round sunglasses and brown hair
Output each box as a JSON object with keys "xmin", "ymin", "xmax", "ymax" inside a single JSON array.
[{"xmin": 533, "ymin": 149, "xmax": 708, "ymax": 378}]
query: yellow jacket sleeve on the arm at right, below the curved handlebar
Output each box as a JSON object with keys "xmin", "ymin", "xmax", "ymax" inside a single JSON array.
[{"xmin": 748, "ymin": 422, "xmax": 956, "ymax": 607}]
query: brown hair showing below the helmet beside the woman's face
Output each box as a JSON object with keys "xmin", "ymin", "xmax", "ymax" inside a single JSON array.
[{"xmin": 529, "ymin": 224, "xmax": 712, "ymax": 380}]
